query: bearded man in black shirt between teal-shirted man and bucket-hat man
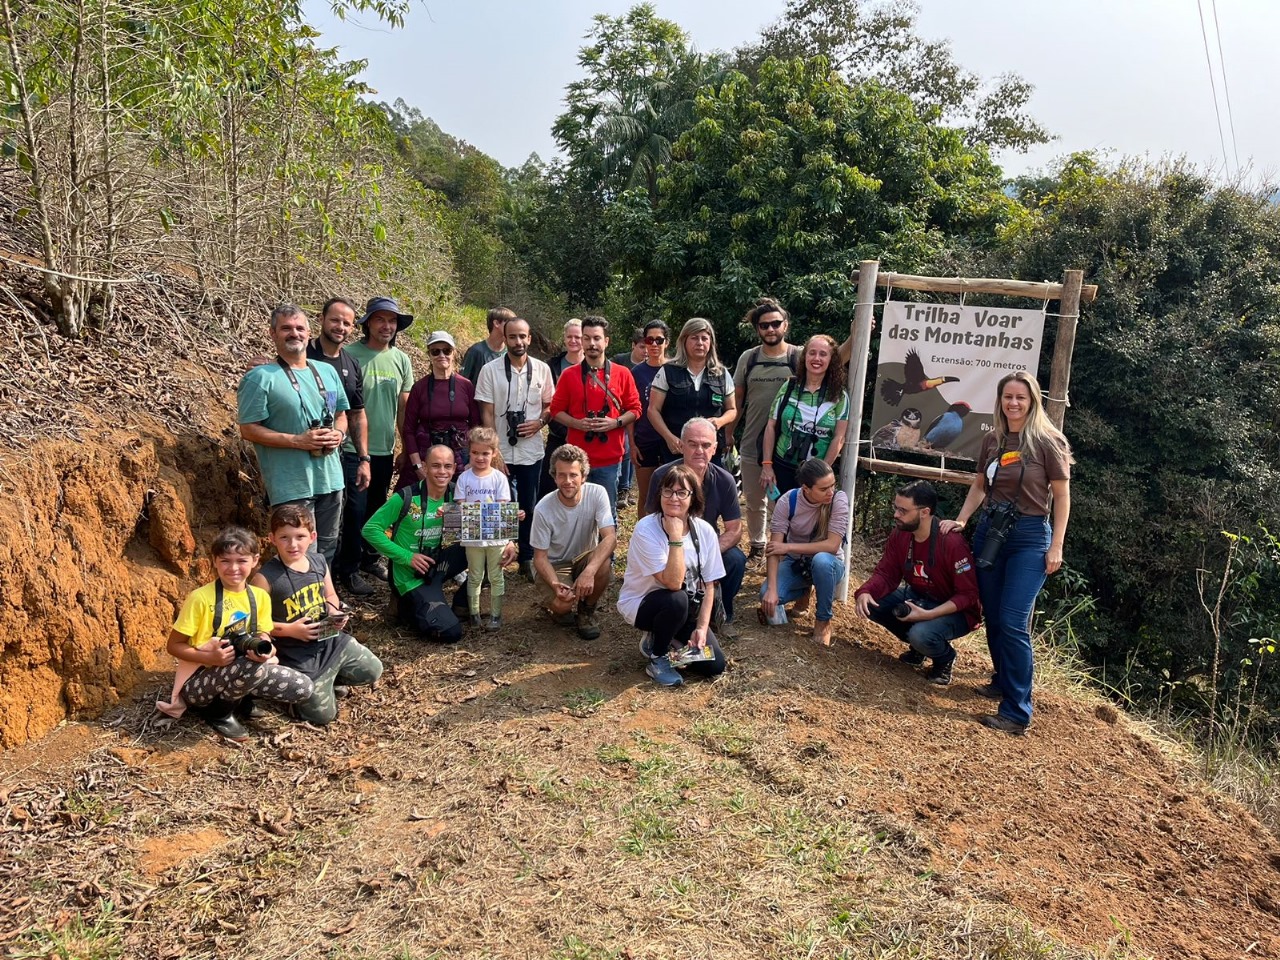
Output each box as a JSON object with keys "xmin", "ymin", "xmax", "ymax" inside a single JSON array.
[{"xmin": 307, "ymin": 297, "xmax": 374, "ymax": 596}]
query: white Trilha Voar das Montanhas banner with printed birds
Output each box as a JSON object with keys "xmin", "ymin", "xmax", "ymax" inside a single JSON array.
[{"xmin": 872, "ymin": 303, "xmax": 1044, "ymax": 460}]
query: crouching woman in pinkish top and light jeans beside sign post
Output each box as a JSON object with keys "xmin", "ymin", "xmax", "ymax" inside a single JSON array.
[{"xmin": 760, "ymin": 457, "xmax": 849, "ymax": 646}]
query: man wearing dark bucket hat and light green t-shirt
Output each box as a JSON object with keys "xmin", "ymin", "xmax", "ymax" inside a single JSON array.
[{"xmin": 335, "ymin": 297, "xmax": 413, "ymax": 595}]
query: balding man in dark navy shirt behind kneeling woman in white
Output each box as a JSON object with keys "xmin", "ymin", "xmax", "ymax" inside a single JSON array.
[{"xmin": 645, "ymin": 417, "xmax": 746, "ymax": 640}]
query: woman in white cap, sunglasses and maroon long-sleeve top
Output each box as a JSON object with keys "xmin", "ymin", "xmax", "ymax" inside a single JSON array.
[{"xmin": 396, "ymin": 330, "xmax": 480, "ymax": 490}]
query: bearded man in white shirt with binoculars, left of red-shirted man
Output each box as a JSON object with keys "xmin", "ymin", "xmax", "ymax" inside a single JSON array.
[{"xmin": 476, "ymin": 317, "xmax": 556, "ymax": 584}]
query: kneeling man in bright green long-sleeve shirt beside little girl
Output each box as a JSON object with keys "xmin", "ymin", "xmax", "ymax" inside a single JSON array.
[{"xmin": 362, "ymin": 444, "xmax": 516, "ymax": 644}]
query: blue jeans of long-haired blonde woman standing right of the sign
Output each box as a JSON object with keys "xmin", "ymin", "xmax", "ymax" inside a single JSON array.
[{"xmin": 973, "ymin": 515, "xmax": 1051, "ymax": 723}]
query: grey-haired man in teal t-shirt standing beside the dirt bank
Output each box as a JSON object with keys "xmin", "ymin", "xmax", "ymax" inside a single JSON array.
[{"xmin": 236, "ymin": 303, "xmax": 349, "ymax": 562}]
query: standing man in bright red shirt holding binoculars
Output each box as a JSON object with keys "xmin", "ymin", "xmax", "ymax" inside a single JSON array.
[{"xmin": 550, "ymin": 316, "xmax": 640, "ymax": 520}]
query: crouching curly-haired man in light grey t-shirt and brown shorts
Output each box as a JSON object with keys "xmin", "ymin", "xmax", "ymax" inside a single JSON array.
[{"xmin": 529, "ymin": 443, "xmax": 617, "ymax": 640}]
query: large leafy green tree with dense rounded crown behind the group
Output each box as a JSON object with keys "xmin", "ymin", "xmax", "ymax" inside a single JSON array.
[{"xmin": 608, "ymin": 58, "xmax": 1012, "ymax": 350}]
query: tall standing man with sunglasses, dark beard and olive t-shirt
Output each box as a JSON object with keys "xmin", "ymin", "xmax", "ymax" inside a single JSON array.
[{"xmin": 733, "ymin": 297, "xmax": 800, "ymax": 562}]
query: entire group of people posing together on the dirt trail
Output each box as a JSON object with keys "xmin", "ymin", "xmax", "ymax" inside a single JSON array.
[{"xmin": 163, "ymin": 297, "xmax": 1070, "ymax": 737}]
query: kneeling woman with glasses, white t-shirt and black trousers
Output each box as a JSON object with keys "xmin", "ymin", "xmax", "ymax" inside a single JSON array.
[{"xmin": 618, "ymin": 463, "xmax": 724, "ymax": 686}]
